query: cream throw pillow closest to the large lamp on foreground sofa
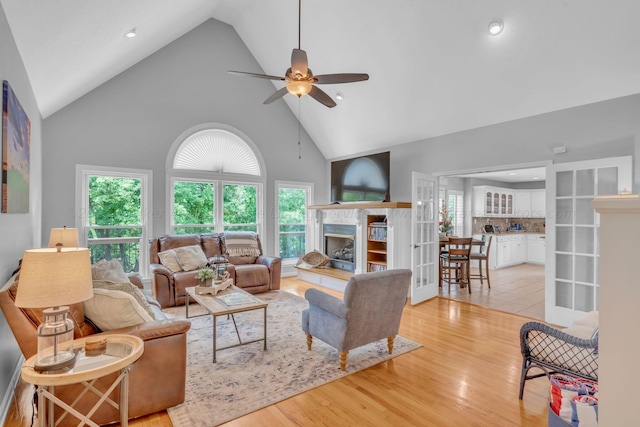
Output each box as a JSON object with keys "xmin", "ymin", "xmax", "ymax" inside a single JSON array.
[{"xmin": 84, "ymin": 288, "xmax": 153, "ymax": 331}]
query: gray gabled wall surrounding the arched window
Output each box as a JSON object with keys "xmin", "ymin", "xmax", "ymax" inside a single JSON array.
[{"xmin": 43, "ymin": 19, "xmax": 328, "ymax": 253}]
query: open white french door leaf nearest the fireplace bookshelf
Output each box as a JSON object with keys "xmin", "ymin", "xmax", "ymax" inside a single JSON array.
[{"xmin": 411, "ymin": 172, "xmax": 439, "ymax": 304}]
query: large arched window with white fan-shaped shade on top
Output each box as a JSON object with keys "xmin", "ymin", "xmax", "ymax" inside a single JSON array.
[{"xmin": 167, "ymin": 123, "xmax": 266, "ymax": 237}]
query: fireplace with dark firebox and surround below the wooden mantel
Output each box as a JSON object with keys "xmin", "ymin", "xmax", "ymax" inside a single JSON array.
[{"xmin": 322, "ymin": 224, "xmax": 356, "ymax": 272}]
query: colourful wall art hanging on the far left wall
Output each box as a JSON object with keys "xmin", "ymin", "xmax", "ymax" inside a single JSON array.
[{"xmin": 2, "ymin": 80, "xmax": 31, "ymax": 213}]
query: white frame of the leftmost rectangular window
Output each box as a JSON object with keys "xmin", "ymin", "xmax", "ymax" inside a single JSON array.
[{"xmin": 75, "ymin": 165, "xmax": 153, "ymax": 278}]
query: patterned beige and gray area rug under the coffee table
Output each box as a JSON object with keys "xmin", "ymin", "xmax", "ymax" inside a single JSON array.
[{"xmin": 164, "ymin": 291, "xmax": 421, "ymax": 427}]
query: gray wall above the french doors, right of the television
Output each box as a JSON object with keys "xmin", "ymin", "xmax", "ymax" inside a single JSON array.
[{"xmin": 384, "ymin": 95, "xmax": 640, "ymax": 201}]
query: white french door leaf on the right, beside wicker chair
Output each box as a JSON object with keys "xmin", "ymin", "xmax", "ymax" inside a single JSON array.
[{"xmin": 545, "ymin": 156, "xmax": 632, "ymax": 326}]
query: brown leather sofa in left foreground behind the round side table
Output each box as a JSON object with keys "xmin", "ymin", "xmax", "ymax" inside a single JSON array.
[{"xmin": 0, "ymin": 274, "xmax": 191, "ymax": 426}]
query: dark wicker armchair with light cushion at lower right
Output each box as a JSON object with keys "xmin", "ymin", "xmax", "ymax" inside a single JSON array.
[{"xmin": 518, "ymin": 322, "xmax": 598, "ymax": 400}]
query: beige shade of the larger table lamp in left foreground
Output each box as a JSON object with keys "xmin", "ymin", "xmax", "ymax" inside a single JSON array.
[{"xmin": 15, "ymin": 247, "xmax": 93, "ymax": 308}]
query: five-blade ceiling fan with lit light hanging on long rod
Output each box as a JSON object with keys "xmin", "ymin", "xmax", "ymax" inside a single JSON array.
[{"xmin": 229, "ymin": 0, "xmax": 369, "ymax": 108}]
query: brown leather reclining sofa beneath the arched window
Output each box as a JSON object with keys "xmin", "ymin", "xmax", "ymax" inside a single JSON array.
[{"xmin": 149, "ymin": 233, "xmax": 282, "ymax": 307}]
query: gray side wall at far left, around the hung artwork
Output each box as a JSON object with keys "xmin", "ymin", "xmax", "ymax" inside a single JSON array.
[{"xmin": 0, "ymin": 7, "xmax": 42, "ymax": 423}]
